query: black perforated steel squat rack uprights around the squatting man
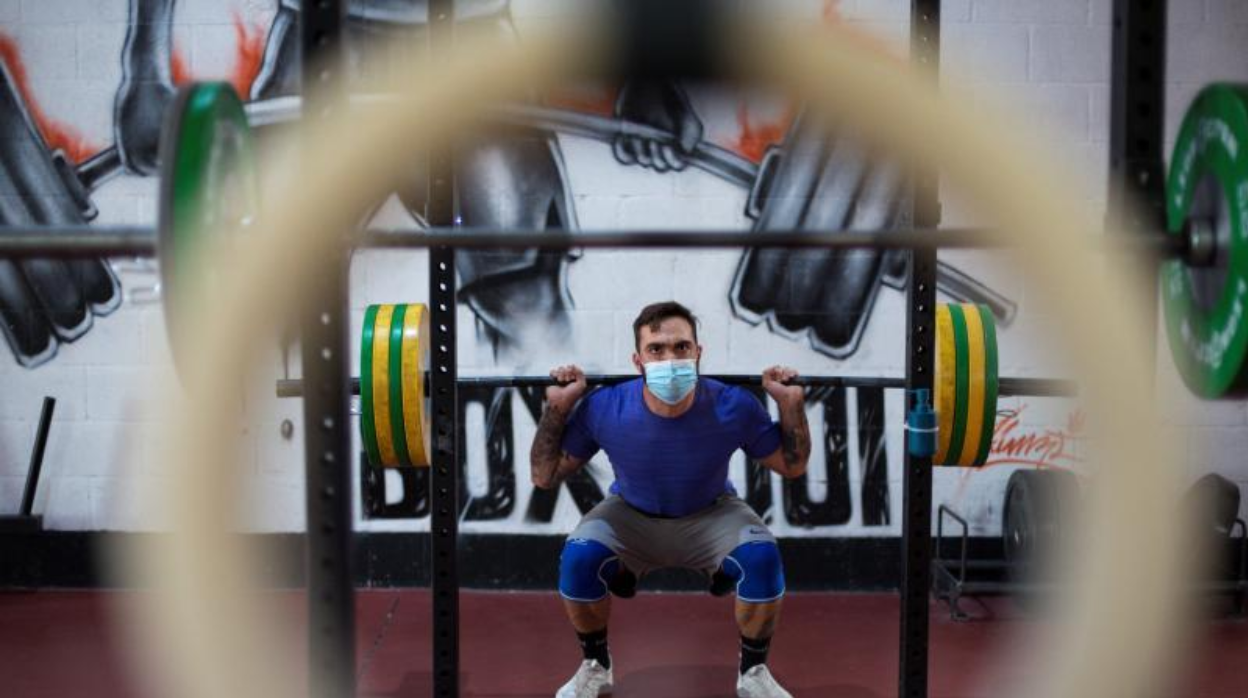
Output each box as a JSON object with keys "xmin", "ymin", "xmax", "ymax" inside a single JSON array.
[{"xmin": 301, "ymin": 0, "xmax": 941, "ymax": 698}]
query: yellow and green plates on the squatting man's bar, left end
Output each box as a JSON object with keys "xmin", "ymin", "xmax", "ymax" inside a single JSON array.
[{"xmin": 359, "ymin": 303, "xmax": 431, "ymax": 467}]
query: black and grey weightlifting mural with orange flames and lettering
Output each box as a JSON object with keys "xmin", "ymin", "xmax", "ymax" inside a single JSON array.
[{"xmin": 0, "ymin": 0, "xmax": 1053, "ymax": 529}]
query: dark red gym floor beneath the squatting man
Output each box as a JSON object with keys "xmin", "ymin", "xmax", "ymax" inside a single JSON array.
[{"xmin": 0, "ymin": 589, "xmax": 1248, "ymax": 698}]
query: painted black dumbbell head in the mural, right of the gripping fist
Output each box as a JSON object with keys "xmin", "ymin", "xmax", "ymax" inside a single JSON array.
[{"xmin": 730, "ymin": 114, "xmax": 1015, "ymax": 358}]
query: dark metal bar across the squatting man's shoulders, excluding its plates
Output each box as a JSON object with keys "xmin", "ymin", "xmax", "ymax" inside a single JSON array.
[{"xmin": 277, "ymin": 373, "xmax": 1080, "ymax": 398}]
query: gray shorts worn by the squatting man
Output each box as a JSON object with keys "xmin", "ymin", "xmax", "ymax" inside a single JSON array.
[{"xmin": 568, "ymin": 494, "xmax": 775, "ymax": 577}]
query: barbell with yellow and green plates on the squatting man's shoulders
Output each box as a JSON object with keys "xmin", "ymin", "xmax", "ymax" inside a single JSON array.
[{"xmin": 277, "ymin": 303, "xmax": 1076, "ymax": 467}]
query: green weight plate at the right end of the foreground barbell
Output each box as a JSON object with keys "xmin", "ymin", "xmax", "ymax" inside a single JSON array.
[{"xmin": 1161, "ymin": 85, "xmax": 1248, "ymax": 398}]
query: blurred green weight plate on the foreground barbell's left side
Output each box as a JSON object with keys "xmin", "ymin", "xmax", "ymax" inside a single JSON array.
[{"xmin": 157, "ymin": 82, "xmax": 258, "ymax": 370}]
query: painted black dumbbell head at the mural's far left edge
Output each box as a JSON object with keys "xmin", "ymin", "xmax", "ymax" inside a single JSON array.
[{"xmin": 0, "ymin": 64, "xmax": 121, "ymax": 367}]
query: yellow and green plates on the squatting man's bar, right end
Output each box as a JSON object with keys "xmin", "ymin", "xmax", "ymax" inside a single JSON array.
[{"xmin": 932, "ymin": 303, "xmax": 998, "ymax": 467}]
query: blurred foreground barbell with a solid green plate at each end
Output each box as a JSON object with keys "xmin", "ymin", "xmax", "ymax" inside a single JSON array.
[{"xmin": 0, "ymin": 82, "xmax": 1248, "ymax": 407}]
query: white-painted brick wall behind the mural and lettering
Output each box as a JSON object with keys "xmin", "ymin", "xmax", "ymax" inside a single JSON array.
[{"xmin": 0, "ymin": 0, "xmax": 1248, "ymax": 534}]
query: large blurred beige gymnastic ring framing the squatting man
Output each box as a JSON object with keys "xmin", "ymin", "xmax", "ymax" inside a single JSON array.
[{"xmin": 134, "ymin": 14, "xmax": 1178, "ymax": 698}]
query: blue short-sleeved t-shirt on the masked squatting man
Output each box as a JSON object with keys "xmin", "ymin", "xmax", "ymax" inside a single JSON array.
[{"xmin": 563, "ymin": 378, "xmax": 780, "ymax": 516}]
